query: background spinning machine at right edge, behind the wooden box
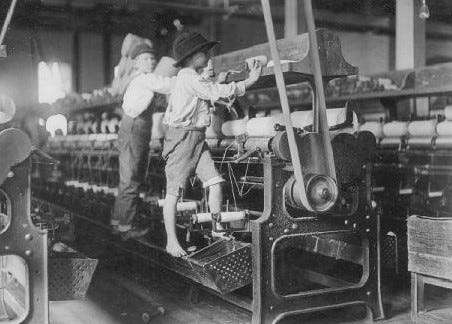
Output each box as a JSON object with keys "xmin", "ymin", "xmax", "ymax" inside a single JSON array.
[{"xmin": 359, "ymin": 106, "xmax": 452, "ymax": 277}]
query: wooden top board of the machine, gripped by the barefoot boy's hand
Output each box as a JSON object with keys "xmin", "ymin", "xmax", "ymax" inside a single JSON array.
[{"xmin": 212, "ymin": 29, "xmax": 358, "ymax": 89}]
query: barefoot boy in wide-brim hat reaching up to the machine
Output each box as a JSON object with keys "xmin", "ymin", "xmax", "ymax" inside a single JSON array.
[{"xmin": 162, "ymin": 32, "xmax": 261, "ymax": 257}]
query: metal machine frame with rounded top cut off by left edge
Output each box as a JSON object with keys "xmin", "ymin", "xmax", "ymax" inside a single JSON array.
[{"xmin": 0, "ymin": 129, "xmax": 49, "ymax": 324}]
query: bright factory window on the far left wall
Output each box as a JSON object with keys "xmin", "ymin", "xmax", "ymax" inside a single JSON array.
[{"xmin": 38, "ymin": 62, "xmax": 72, "ymax": 104}]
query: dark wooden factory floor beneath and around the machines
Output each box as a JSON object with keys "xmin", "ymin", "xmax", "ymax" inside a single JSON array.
[{"xmin": 50, "ymin": 265, "xmax": 452, "ymax": 324}]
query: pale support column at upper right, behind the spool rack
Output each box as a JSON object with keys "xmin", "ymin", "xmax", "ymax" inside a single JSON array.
[{"xmin": 395, "ymin": 0, "xmax": 429, "ymax": 117}]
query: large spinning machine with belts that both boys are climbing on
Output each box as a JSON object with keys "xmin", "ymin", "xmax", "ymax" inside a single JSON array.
[{"xmin": 34, "ymin": 0, "xmax": 384, "ymax": 323}]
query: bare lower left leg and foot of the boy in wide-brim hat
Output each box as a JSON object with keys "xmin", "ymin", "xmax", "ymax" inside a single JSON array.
[{"xmin": 163, "ymin": 195, "xmax": 187, "ymax": 257}]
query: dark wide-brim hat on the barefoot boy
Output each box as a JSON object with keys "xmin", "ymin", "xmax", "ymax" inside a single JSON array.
[{"xmin": 173, "ymin": 32, "xmax": 220, "ymax": 67}]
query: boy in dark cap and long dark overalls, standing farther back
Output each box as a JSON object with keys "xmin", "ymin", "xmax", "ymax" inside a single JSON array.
[{"xmin": 111, "ymin": 42, "xmax": 175, "ymax": 239}]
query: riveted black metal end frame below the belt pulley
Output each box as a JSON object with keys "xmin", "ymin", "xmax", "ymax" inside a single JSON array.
[{"xmin": 251, "ymin": 159, "xmax": 384, "ymax": 324}]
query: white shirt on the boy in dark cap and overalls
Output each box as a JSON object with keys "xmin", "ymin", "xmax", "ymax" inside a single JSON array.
[{"xmin": 122, "ymin": 73, "xmax": 176, "ymax": 118}]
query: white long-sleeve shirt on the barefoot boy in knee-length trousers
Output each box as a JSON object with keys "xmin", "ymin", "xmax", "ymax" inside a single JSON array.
[{"xmin": 164, "ymin": 68, "xmax": 245, "ymax": 128}]
